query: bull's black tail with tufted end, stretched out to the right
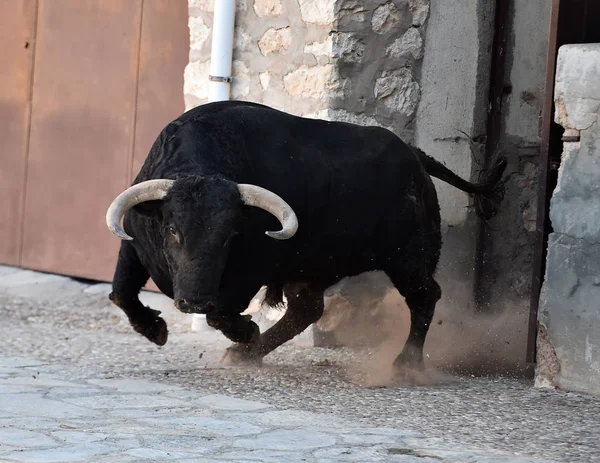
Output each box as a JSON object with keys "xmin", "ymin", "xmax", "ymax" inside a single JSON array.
[{"xmin": 411, "ymin": 146, "xmax": 507, "ymax": 220}]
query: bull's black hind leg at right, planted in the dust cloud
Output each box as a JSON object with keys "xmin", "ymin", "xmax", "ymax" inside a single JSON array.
[{"xmin": 386, "ymin": 265, "xmax": 442, "ymax": 368}]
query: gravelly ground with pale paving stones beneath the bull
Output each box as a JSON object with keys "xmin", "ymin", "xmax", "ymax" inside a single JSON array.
[{"xmin": 0, "ymin": 267, "xmax": 600, "ymax": 463}]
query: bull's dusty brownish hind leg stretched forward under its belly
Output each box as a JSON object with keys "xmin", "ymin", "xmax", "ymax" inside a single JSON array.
[{"xmin": 223, "ymin": 286, "xmax": 324, "ymax": 364}]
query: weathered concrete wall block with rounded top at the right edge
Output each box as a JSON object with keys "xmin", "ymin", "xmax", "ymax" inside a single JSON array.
[{"xmin": 536, "ymin": 44, "xmax": 600, "ymax": 394}]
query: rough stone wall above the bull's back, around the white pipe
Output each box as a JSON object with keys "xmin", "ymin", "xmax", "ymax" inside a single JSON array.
[{"xmin": 184, "ymin": 0, "xmax": 429, "ymax": 141}]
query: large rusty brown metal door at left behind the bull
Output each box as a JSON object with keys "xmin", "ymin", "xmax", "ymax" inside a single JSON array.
[{"xmin": 0, "ymin": 0, "xmax": 189, "ymax": 280}]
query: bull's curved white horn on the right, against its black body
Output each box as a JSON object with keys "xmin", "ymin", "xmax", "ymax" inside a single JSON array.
[{"xmin": 238, "ymin": 183, "xmax": 298, "ymax": 240}]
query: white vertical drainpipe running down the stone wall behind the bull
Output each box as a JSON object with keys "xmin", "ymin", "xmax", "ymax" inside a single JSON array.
[{"xmin": 192, "ymin": 0, "xmax": 236, "ymax": 332}]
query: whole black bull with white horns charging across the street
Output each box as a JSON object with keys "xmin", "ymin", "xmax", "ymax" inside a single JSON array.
[{"xmin": 107, "ymin": 102, "xmax": 506, "ymax": 365}]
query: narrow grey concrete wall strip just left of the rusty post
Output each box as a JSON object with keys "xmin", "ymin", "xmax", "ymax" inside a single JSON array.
[{"xmin": 484, "ymin": 0, "xmax": 550, "ymax": 312}]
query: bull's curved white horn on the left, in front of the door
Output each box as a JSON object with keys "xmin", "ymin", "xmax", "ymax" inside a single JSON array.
[{"xmin": 106, "ymin": 179, "xmax": 175, "ymax": 241}]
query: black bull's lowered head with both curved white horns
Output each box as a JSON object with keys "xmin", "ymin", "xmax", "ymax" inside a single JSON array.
[{"xmin": 106, "ymin": 177, "xmax": 298, "ymax": 313}]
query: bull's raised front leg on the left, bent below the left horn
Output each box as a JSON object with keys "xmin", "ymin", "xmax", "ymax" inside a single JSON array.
[{"xmin": 109, "ymin": 242, "xmax": 168, "ymax": 346}]
